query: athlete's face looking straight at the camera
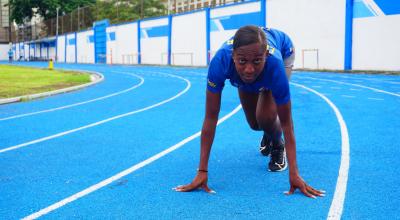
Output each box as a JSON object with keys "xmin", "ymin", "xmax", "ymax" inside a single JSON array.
[{"xmin": 233, "ymin": 43, "xmax": 267, "ymax": 83}]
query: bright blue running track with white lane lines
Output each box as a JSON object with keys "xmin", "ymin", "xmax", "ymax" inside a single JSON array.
[{"xmin": 0, "ymin": 62, "xmax": 400, "ymax": 219}]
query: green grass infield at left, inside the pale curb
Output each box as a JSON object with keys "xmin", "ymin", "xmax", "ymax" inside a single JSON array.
[{"xmin": 0, "ymin": 65, "xmax": 90, "ymax": 98}]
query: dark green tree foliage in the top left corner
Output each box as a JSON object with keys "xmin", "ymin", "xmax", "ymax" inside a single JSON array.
[{"xmin": 9, "ymin": 0, "xmax": 96, "ymax": 24}]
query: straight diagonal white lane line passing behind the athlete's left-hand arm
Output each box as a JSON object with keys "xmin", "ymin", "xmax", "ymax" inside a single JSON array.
[{"xmin": 23, "ymin": 105, "xmax": 241, "ymax": 219}]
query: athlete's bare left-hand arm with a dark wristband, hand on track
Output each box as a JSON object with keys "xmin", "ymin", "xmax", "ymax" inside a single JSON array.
[{"xmin": 175, "ymin": 90, "xmax": 221, "ymax": 193}]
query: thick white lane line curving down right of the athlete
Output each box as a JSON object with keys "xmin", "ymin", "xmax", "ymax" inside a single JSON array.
[{"xmin": 292, "ymin": 83, "xmax": 350, "ymax": 220}]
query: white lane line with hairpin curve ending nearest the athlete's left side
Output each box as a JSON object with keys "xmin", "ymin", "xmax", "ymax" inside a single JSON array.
[{"xmin": 0, "ymin": 73, "xmax": 191, "ymax": 153}]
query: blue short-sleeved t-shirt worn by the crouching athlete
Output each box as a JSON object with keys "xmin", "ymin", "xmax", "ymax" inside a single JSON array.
[{"xmin": 207, "ymin": 28, "xmax": 293, "ymax": 105}]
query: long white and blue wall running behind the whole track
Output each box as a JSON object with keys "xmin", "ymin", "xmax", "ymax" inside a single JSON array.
[{"xmin": 17, "ymin": 0, "xmax": 400, "ymax": 70}]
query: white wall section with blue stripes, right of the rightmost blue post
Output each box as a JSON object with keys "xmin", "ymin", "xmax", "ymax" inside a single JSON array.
[{"xmin": 352, "ymin": 0, "xmax": 400, "ymax": 70}]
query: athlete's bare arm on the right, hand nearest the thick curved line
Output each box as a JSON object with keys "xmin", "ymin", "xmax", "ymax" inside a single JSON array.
[{"xmin": 277, "ymin": 101, "xmax": 325, "ymax": 198}]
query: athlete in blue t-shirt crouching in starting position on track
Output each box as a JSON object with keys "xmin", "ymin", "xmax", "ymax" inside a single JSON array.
[{"xmin": 175, "ymin": 25, "xmax": 325, "ymax": 198}]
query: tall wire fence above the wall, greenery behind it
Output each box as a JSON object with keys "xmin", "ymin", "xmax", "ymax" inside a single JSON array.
[{"xmin": 7, "ymin": 0, "xmax": 244, "ymax": 43}]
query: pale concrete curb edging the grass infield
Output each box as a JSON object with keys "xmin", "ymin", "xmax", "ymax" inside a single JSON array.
[{"xmin": 0, "ymin": 69, "xmax": 104, "ymax": 105}]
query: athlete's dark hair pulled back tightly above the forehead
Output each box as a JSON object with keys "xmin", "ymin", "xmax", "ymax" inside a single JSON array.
[{"xmin": 233, "ymin": 25, "xmax": 267, "ymax": 50}]
